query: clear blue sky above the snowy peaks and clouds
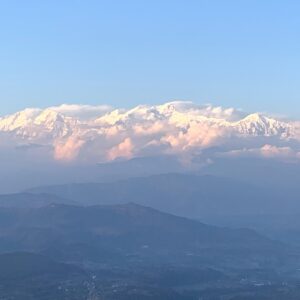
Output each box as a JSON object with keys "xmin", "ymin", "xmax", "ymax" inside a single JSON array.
[{"xmin": 0, "ymin": 0, "xmax": 300, "ymax": 117}]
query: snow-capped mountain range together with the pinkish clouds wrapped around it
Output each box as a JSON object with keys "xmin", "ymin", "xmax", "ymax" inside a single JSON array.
[{"xmin": 0, "ymin": 101, "xmax": 300, "ymax": 165}]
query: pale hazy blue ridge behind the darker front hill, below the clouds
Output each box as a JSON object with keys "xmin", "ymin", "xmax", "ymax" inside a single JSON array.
[{"xmin": 29, "ymin": 174, "xmax": 300, "ymax": 218}]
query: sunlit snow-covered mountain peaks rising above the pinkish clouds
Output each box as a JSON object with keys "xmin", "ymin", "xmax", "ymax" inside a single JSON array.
[{"xmin": 0, "ymin": 101, "xmax": 292, "ymax": 141}]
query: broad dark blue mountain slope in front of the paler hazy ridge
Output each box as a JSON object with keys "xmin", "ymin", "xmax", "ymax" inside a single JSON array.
[{"xmin": 0, "ymin": 204, "xmax": 286, "ymax": 268}]
